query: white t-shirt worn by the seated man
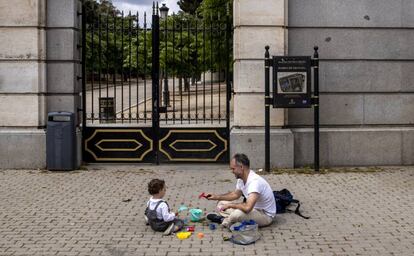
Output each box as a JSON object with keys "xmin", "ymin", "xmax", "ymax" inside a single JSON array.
[{"xmin": 236, "ymin": 170, "xmax": 276, "ymax": 218}]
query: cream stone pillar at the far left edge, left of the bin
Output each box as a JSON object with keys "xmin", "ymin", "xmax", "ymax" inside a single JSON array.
[{"xmin": 0, "ymin": 0, "xmax": 46, "ymax": 168}]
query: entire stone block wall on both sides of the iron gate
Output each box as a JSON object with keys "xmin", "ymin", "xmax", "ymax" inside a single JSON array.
[{"xmin": 0, "ymin": 0, "xmax": 414, "ymax": 168}]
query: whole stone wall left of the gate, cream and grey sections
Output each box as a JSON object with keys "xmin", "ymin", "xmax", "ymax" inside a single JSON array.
[{"xmin": 0, "ymin": 0, "xmax": 80, "ymax": 168}]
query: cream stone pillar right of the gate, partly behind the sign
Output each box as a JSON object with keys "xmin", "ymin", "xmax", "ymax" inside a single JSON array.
[{"xmin": 230, "ymin": 0, "xmax": 293, "ymax": 168}]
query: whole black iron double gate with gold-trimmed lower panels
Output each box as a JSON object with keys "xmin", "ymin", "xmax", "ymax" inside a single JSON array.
[{"xmin": 82, "ymin": 4, "xmax": 232, "ymax": 163}]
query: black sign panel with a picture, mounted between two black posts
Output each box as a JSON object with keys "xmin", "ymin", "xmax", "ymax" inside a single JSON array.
[{"xmin": 273, "ymin": 56, "xmax": 311, "ymax": 108}]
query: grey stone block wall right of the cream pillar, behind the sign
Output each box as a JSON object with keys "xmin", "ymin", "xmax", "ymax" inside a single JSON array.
[{"xmin": 288, "ymin": 0, "xmax": 414, "ymax": 166}]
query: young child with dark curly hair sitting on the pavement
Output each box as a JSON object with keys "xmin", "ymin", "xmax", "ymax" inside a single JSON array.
[{"xmin": 145, "ymin": 179, "xmax": 184, "ymax": 235}]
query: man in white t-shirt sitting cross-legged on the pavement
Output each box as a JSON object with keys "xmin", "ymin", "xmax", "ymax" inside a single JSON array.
[{"xmin": 206, "ymin": 154, "xmax": 276, "ymax": 227}]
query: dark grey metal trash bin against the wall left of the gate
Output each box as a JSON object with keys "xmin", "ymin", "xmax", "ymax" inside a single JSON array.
[{"xmin": 46, "ymin": 112, "xmax": 76, "ymax": 171}]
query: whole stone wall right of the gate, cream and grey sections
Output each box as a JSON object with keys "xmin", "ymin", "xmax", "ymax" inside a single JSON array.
[{"xmin": 231, "ymin": 0, "xmax": 414, "ymax": 167}]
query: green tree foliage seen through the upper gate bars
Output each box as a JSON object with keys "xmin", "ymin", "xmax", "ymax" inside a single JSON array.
[{"xmin": 85, "ymin": 0, "xmax": 232, "ymax": 82}]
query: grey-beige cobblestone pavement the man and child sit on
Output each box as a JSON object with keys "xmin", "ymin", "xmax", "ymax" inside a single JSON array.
[{"xmin": 0, "ymin": 165, "xmax": 414, "ymax": 256}]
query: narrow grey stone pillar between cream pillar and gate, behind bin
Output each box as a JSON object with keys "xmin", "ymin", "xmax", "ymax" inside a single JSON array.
[{"xmin": 46, "ymin": 0, "xmax": 82, "ymax": 165}]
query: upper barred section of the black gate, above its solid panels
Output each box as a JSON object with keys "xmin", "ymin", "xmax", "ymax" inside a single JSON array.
[{"xmin": 82, "ymin": 3, "xmax": 232, "ymax": 127}]
